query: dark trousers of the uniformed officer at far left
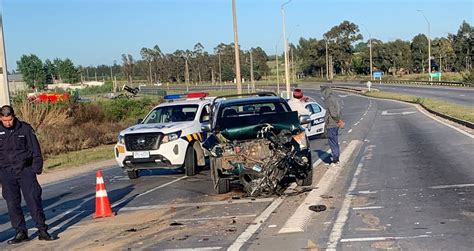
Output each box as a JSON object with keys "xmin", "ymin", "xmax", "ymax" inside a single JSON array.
[{"xmin": 0, "ymin": 167, "xmax": 48, "ymax": 231}]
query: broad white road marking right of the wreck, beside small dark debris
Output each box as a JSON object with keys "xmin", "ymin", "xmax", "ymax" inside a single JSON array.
[{"xmin": 278, "ymin": 140, "xmax": 362, "ymax": 234}]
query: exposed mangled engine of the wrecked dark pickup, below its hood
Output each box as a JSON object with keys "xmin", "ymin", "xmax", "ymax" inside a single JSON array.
[{"xmin": 208, "ymin": 124, "xmax": 310, "ymax": 196}]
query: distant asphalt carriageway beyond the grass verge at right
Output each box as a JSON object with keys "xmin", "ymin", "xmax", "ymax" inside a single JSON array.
[{"xmin": 341, "ymin": 81, "xmax": 474, "ymax": 106}]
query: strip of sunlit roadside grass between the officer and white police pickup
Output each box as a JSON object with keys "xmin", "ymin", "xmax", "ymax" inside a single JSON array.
[{"xmin": 44, "ymin": 145, "xmax": 114, "ymax": 170}]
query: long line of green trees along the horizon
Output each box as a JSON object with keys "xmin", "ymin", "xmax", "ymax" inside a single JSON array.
[{"xmin": 13, "ymin": 21, "xmax": 474, "ymax": 89}]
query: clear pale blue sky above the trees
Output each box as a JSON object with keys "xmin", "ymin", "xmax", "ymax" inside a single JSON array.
[{"xmin": 0, "ymin": 0, "xmax": 474, "ymax": 70}]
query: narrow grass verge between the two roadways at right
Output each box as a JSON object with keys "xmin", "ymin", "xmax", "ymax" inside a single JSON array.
[{"xmin": 365, "ymin": 91, "xmax": 474, "ymax": 123}]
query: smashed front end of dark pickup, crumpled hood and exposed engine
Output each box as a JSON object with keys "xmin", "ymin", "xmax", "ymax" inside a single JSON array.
[{"xmin": 204, "ymin": 106, "xmax": 312, "ymax": 196}]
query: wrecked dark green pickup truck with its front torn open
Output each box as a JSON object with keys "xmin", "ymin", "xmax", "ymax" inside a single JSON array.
[{"xmin": 202, "ymin": 92, "xmax": 313, "ymax": 196}]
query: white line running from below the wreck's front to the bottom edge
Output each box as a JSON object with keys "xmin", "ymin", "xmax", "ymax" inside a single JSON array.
[{"xmin": 227, "ymin": 197, "xmax": 283, "ymax": 251}]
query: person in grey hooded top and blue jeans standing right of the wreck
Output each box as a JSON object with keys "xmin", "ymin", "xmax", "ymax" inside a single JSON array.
[{"xmin": 321, "ymin": 85, "xmax": 345, "ymax": 165}]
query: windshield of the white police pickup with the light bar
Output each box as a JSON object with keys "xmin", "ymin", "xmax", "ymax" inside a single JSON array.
[{"xmin": 143, "ymin": 105, "xmax": 199, "ymax": 124}]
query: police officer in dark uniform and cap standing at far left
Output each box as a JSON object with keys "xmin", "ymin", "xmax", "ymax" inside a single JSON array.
[{"xmin": 0, "ymin": 105, "xmax": 53, "ymax": 244}]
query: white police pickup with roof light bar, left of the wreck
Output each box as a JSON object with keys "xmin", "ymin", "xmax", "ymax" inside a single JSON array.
[{"xmin": 115, "ymin": 93, "xmax": 211, "ymax": 179}]
